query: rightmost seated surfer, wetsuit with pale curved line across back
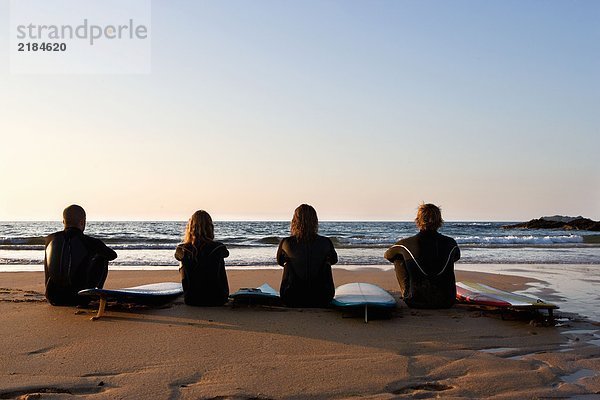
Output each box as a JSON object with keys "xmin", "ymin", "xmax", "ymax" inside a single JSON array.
[{"xmin": 384, "ymin": 204, "xmax": 460, "ymax": 308}]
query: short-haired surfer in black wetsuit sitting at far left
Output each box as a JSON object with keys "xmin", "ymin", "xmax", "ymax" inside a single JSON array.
[{"xmin": 44, "ymin": 204, "xmax": 117, "ymax": 306}]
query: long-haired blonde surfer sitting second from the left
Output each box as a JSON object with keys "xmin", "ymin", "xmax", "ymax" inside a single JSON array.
[{"xmin": 175, "ymin": 210, "xmax": 229, "ymax": 306}]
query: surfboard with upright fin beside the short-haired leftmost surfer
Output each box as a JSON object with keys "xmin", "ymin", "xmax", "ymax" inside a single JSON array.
[{"xmin": 78, "ymin": 282, "xmax": 183, "ymax": 320}]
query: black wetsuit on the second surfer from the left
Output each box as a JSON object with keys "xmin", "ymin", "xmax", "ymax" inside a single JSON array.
[{"xmin": 175, "ymin": 242, "xmax": 229, "ymax": 306}]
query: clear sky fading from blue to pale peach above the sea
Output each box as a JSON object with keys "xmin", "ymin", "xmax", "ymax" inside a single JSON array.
[{"xmin": 0, "ymin": 0, "xmax": 600, "ymax": 220}]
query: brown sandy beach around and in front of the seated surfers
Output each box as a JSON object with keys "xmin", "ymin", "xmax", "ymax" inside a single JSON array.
[{"xmin": 0, "ymin": 269, "xmax": 600, "ymax": 399}]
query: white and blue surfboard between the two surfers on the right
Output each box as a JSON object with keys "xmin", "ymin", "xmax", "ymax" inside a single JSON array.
[{"xmin": 331, "ymin": 282, "xmax": 396, "ymax": 322}]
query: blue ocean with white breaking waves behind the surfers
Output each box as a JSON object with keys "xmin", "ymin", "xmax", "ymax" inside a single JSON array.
[{"xmin": 0, "ymin": 221, "xmax": 600, "ymax": 271}]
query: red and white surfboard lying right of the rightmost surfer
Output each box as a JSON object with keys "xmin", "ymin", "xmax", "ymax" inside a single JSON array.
[{"xmin": 456, "ymin": 281, "xmax": 559, "ymax": 318}]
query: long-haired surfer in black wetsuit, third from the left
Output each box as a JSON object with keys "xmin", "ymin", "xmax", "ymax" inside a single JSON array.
[{"xmin": 277, "ymin": 204, "xmax": 338, "ymax": 307}]
